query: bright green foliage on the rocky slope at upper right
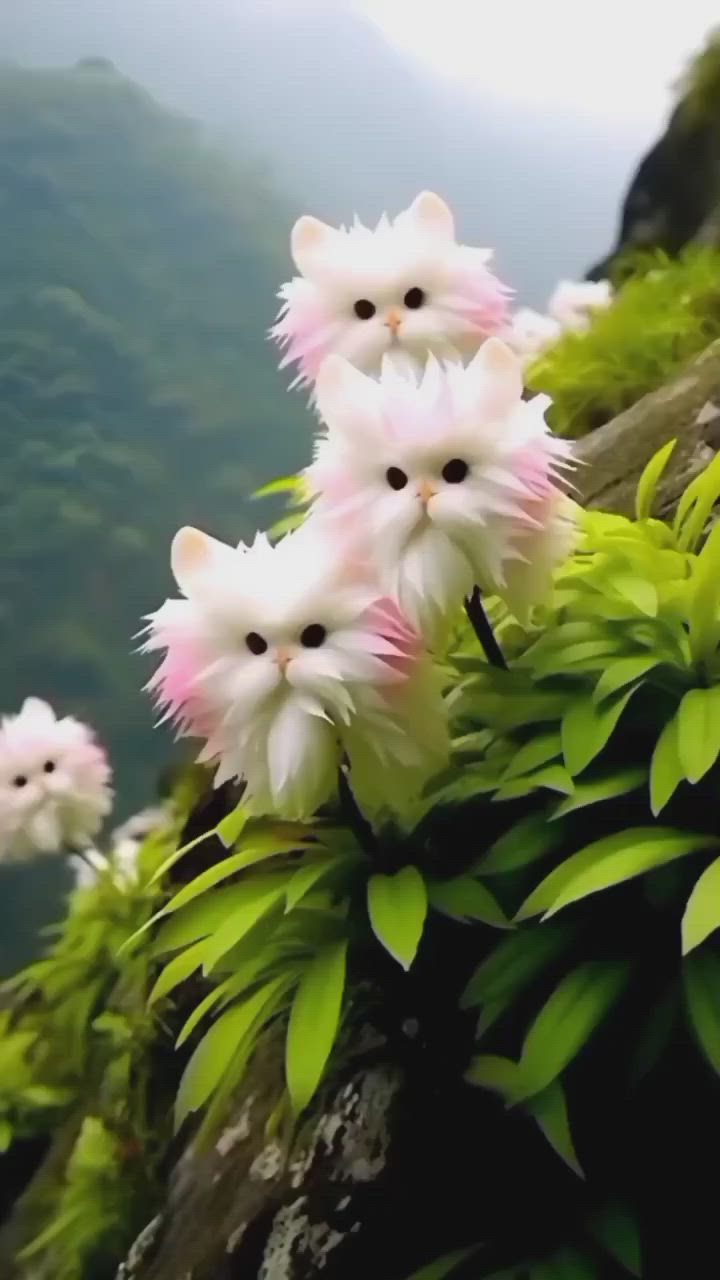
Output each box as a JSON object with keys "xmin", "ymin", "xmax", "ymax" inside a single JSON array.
[{"xmin": 527, "ymin": 247, "xmax": 720, "ymax": 436}]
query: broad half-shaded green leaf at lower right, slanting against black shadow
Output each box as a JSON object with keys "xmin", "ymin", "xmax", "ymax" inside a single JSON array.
[{"xmin": 514, "ymin": 961, "xmax": 628, "ymax": 1102}]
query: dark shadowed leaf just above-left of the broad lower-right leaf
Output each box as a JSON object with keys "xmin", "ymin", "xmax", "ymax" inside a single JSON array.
[{"xmin": 460, "ymin": 920, "xmax": 578, "ymax": 1009}]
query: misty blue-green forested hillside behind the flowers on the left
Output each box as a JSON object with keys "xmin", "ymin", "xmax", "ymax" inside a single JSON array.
[{"xmin": 0, "ymin": 60, "xmax": 301, "ymax": 808}]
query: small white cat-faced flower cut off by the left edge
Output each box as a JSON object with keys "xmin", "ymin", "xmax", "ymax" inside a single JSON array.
[{"xmin": 0, "ymin": 698, "xmax": 113, "ymax": 861}]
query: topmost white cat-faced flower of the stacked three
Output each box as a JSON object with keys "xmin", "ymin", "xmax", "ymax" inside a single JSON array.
[{"xmin": 270, "ymin": 191, "xmax": 510, "ymax": 385}]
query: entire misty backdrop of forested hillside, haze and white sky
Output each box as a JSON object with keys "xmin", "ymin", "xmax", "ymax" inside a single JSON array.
[{"xmin": 0, "ymin": 0, "xmax": 717, "ymax": 818}]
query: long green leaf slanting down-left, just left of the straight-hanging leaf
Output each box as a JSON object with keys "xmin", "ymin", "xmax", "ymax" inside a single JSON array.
[{"xmin": 176, "ymin": 975, "xmax": 287, "ymax": 1129}]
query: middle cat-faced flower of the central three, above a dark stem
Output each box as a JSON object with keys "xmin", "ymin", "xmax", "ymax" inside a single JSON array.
[{"xmin": 305, "ymin": 338, "xmax": 574, "ymax": 644}]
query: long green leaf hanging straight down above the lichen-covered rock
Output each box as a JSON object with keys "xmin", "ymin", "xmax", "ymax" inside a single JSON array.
[{"xmin": 286, "ymin": 941, "xmax": 347, "ymax": 1115}]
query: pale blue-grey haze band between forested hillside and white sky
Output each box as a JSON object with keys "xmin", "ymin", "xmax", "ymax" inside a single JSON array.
[{"xmin": 0, "ymin": 0, "xmax": 642, "ymax": 305}]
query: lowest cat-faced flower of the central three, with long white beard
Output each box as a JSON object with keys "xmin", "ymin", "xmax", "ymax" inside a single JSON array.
[{"xmin": 145, "ymin": 520, "xmax": 447, "ymax": 817}]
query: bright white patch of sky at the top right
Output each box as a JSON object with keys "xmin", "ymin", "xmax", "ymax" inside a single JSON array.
[{"xmin": 355, "ymin": 0, "xmax": 720, "ymax": 133}]
